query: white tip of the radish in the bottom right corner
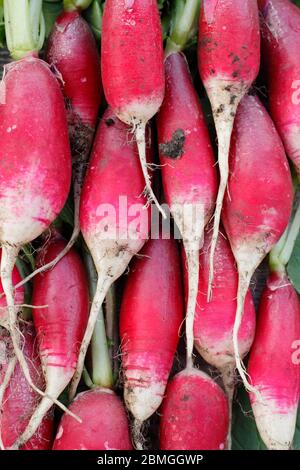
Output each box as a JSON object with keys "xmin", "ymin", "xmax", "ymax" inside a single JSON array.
[{"xmin": 252, "ymin": 399, "xmax": 298, "ymax": 450}]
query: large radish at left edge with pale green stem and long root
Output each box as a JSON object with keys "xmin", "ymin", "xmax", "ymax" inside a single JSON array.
[{"xmin": 0, "ymin": 0, "xmax": 71, "ymax": 404}]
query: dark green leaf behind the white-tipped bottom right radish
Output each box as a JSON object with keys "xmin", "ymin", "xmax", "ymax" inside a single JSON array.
[{"xmin": 232, "ymin": 387, "xmax": 300, "ymax": 450}]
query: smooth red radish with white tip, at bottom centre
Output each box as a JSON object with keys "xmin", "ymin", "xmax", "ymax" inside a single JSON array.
[{"xmin": 120, "ymin": 235, "xmax": 183, "ymax": 449}]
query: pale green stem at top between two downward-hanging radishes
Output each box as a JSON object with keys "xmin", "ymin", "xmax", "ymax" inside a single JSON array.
[{"xmin": 165, "ymin": 0, "xmax": 200, "ymax": 56}]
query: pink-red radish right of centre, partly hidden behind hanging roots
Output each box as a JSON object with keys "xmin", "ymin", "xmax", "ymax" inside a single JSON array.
[{"xmin": 185, "ymin": 224, "xmax": 255, "ymax": 401}]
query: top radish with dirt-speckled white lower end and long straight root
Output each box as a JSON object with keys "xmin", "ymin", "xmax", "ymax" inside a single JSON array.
[{"xmin": 198, "ymin": 0, "xmax": 260, "ymax": 298}]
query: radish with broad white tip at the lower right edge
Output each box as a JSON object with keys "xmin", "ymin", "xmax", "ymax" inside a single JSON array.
[{"xmin": 248, "ymin": 272, "xmax": 300, "ymax": 450}]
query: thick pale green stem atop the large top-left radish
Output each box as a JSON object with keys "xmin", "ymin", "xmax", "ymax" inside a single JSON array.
[{"xmin": 4, "ymin": 0, "xmax": 45, "ymax": 60}]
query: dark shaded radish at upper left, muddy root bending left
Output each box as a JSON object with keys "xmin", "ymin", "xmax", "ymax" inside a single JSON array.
[{"xmin": 17, "ymin": 0, "xmax": 101, "ymax": 283}]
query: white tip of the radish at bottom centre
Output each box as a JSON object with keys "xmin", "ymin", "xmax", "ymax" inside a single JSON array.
[{"xmin": 124, "ymin": 382, "xmax": 166, "ymax": 422}]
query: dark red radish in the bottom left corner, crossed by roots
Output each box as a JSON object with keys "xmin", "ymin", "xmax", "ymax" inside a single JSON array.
[{"xmin": 0, "ymin": 323, "xmax": 53, "ymax": 450}]
